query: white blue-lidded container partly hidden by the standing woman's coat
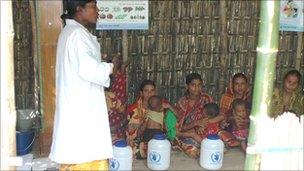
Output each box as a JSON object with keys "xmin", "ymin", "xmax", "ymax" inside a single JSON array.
[{"xmin": 109, "ymin": 140, "xmax": 132, "ymax": 171}]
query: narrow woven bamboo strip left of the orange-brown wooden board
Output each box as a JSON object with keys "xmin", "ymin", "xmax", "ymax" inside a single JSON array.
[{"xmin": 13, "ymin": 0, "xmax": 35, "ymax": 109}]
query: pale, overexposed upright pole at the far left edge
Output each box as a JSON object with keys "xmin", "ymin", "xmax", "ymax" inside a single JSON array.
[{"xmin": 0, "ymin": 1, "xmax": 16, "ymax": 170}]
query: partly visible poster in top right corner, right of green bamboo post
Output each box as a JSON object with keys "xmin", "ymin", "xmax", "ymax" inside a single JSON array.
[{"xmin": 280, "ymin": 0, "xmax": 304, "ymax": 32}]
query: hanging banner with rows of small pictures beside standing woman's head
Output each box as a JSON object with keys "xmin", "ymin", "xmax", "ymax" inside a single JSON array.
[{"xmin": 96, "ymin": 0, "xmax": 149, "ymax": 30}]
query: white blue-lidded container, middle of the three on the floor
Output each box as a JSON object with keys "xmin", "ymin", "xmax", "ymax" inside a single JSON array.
[{"xmin": 147, "ymin": 133, "xmax": 171, "ymax": 170}]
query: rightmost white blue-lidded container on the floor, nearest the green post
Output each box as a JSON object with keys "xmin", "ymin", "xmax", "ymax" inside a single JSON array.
[{"xmin": 200, "ymin": 134, "xmax": 224, "ymax": 170}]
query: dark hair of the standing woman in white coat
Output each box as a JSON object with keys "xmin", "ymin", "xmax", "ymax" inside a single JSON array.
[{"xmin": 60, "ymin": 0, "xmax": 96, "ymax": 21}]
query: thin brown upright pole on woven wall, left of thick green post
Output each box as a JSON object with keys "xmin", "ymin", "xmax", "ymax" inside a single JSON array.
[{"xmin": 219, "ymin": 0, "xmax": 228, "ymax": 94}]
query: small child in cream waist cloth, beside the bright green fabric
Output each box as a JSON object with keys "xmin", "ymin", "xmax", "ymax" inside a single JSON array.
[{"xmin": 138, "ymin": 95, "xmax": 164, "ymax": 142}]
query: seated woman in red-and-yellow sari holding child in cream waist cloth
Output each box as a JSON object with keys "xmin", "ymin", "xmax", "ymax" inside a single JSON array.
[{"xmin": 126, "ymin": 80, "xmax": 175, "ymax": 159}]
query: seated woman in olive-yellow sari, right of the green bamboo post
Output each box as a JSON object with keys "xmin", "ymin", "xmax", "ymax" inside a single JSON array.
[{"xmin": 269, "ymin": 70, "xmax": 304, "ymax": 118}]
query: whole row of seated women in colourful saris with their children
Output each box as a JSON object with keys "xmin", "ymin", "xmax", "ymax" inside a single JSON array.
[{"xmin": 107, "ymin": 70, "xmax": 304, "ymax": 159}]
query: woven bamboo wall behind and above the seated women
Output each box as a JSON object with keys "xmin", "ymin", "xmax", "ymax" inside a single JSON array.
[{"xmin": 97, "ymin": 0, "xmax": 304, "ymax": 102}]
